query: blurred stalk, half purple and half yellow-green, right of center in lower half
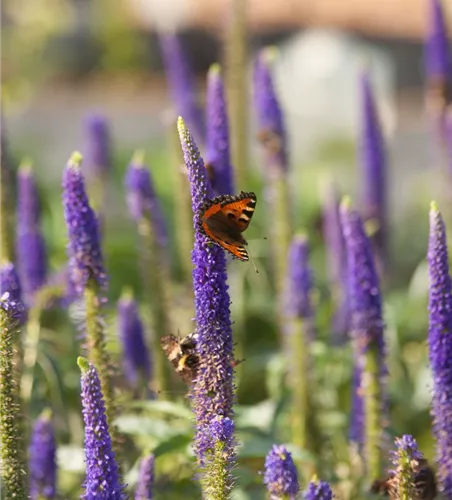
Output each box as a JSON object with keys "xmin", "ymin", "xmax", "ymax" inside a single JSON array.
[{"xmin": 285, "ymin": 234, "xmax": 314, "ymax": 447}]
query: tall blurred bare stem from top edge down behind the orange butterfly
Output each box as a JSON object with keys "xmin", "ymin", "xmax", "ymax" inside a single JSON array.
[{"xmin": 225, "ymin": 0, "xmax": 248, "ymax": 186}]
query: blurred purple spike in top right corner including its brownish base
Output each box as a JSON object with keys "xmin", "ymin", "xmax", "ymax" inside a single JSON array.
[{"xmin": 425, "ymin": 0, "xmax": 452, "ymax": 113}]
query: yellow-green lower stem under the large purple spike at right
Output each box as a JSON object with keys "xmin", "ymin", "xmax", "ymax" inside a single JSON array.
[{"xmin": 362, "ymin": 346, "xmax": 383, "ymax": 482}]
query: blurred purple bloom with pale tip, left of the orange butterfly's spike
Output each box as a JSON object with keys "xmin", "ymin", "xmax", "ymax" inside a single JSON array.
[{"xmin": 125, "ymin": 151, "xmax": 168, "ymax": 246}]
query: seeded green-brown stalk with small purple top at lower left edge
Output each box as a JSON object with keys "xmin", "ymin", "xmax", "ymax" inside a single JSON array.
[{"xmin": 0, "ymin": 292, "xmax": 28, "ymax": 500}]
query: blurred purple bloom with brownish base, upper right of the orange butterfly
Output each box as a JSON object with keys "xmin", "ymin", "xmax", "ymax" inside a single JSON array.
[{"xmin": 254, "ymin": 48, "xmax": 288, "ymax": 171}]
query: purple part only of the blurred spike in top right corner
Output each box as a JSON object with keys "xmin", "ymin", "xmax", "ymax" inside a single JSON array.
[{"xmin": 425, "ymin": 0, "xmax": 452, "ymax": 82}]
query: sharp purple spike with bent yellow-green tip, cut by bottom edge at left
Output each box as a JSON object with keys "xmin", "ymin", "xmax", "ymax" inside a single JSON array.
[{"xmin": 77, "ymin": 357, "xmax": 126, "ymax": 500}]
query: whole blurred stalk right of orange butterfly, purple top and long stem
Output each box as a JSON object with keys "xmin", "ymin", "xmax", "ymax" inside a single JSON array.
[{"xmin": 254, "ymin": 48, "xmax": 293, "ymax": 322}]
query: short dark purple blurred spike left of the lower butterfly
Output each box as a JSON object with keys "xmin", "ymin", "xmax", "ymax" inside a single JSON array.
[{"xmin": 118, "ymin": 292, "xmax": 151, "ymax": 386}]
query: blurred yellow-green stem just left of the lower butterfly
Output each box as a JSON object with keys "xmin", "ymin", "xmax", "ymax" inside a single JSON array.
[{"xmin": 138, "ymin": 218, "xmax": 172, "ymax": 398}]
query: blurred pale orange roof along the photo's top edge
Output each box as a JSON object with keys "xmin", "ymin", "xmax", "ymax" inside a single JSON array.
[{"xmin": 129, "ymin": 0, "xmax": 452, "ymax": 40}]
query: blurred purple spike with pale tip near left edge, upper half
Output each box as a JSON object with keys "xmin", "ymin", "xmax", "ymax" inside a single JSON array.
[{"xmin": 16, "ymin": 164, "xmax": 47, "ymax": 301}]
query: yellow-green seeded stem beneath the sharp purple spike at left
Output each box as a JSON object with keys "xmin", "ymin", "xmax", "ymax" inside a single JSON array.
[{"xmin": 84, "ymin": 278, "xmax": 121, "ymax": 456}]
